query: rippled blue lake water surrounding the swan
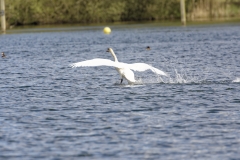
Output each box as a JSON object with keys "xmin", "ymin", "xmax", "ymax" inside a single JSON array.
[{"xmin": 0, "ymin": 23, "xmax": 240, "ymax": 160}]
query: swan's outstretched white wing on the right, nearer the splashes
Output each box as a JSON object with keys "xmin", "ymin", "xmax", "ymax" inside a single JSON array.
[{"xmin": 125, "ymin": 63, "xmax": 168, "ymax": 76}]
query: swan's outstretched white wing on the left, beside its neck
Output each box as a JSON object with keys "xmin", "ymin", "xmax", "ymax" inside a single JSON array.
[{"xmin": 70, "ymin": 58, "xmax": 116, "ymax": 68}]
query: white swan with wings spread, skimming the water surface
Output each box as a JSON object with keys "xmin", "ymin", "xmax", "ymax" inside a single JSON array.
[{"xmin": 70, "ymin": 48, "xmax": 168, "ymax": 84}]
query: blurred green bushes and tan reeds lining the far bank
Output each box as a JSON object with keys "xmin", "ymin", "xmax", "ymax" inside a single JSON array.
[{"xmin": 5, "ymin": 0, "xmax": 240, "ymax": 25}]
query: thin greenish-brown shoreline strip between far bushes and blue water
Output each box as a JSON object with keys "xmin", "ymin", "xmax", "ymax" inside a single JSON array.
[{"xmin": 6, "ymin": 19, "xmax": 240, "ymax": 34}]
